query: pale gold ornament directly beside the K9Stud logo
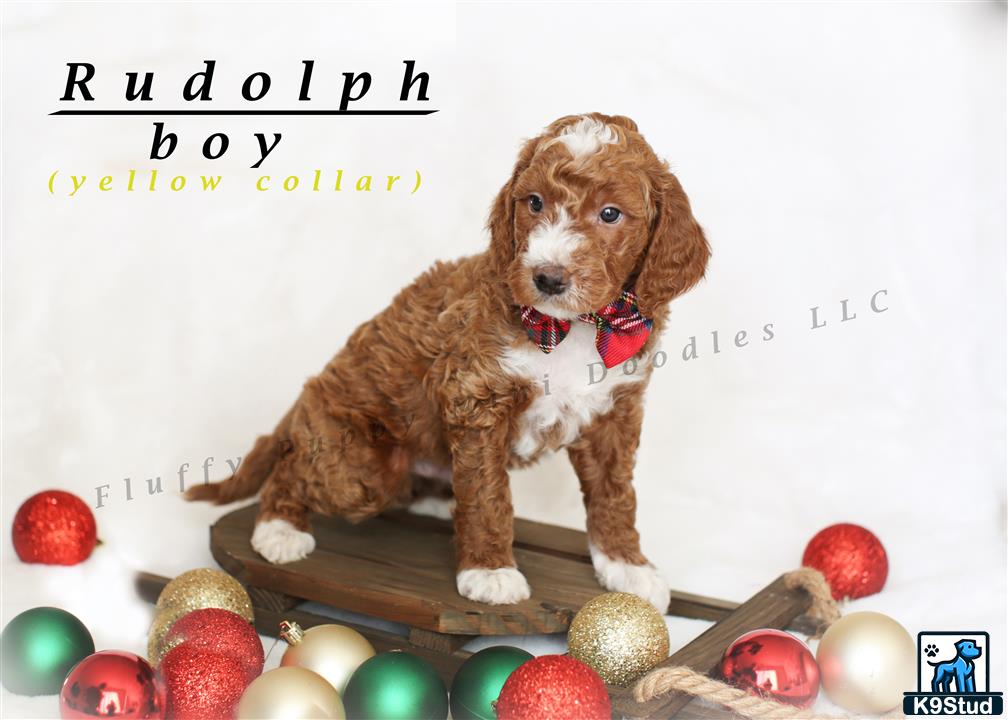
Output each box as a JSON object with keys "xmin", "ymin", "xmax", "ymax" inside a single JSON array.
[{"xmin": 815, "ymin": 612, "xmax": 917, "ymax": 715}]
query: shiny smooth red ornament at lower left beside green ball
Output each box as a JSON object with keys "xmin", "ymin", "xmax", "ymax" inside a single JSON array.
[{"xmin": 59, "ymin": 650, "xmax": 164, "ymax": 720}]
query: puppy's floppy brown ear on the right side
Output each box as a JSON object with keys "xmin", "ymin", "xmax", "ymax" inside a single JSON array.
[{"xmin": 634, "ymin": 168, "xmax": 711, "ymax": 317}]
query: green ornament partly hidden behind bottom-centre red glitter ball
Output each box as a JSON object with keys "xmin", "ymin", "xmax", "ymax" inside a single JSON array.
[{"xmin": 452, "ymin": 645, "xmax": 532, "ymax": 720}]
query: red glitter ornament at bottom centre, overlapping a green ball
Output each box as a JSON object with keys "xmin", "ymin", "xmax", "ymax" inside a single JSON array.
[{"xmin": 496, "ymin": 655, "xmax": 613, "ymax": 720}]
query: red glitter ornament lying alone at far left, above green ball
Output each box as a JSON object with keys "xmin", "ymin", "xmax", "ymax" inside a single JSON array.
[{"xmin": 11, "ymin": 490, "xmax": 98, "ymax": 565}]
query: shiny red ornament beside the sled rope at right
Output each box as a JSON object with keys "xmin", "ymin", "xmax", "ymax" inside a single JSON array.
[{"xmin": 721, "ymin": 628, "xmax": 820, "ymax": 708}]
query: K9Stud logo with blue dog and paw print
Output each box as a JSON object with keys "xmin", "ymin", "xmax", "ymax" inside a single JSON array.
[{"xmin": 903, "ymin": 631, "xmax": 1004, "ymax": 715}]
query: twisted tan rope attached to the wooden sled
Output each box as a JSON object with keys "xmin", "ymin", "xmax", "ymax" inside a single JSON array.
[{"xmin": 633, "ymin": 568, "xmax": 903, "ymax": 720}]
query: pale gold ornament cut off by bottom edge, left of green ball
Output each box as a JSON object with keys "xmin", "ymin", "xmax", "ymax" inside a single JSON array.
[{"xmin": 236, "ymin": 668, "xmax": 347, "ymax": 720}]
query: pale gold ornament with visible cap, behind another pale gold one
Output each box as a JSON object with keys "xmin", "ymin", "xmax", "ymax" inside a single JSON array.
[{"xmin": 280, "ymin": 620, "xmax": 375, "ymax": 695}]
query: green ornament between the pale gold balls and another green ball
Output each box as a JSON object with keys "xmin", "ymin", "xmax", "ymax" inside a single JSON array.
[{"xmin": 343, "ymin": 650, "xmax": 448, "ymax": 720}]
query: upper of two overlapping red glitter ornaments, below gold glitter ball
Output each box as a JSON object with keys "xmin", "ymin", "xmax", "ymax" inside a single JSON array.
[{"xmin": 161, "ymin": 607, "xmax": 264, "ymax": 683}]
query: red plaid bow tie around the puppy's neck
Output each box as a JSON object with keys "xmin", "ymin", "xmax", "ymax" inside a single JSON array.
[{"xmin": 521, "ymin": 290, "xmax": 651, "ymax": 368}]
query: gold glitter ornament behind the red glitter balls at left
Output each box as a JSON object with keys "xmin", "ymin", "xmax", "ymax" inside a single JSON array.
[{"xmin": 147, "ymin": 568, "xmax": 255, "ymax": 665}]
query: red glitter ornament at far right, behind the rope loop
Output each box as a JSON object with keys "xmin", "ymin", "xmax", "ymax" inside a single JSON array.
[{"xmin": 801, "ymin": 522, "xmax": 889, "ymax": 600}]
